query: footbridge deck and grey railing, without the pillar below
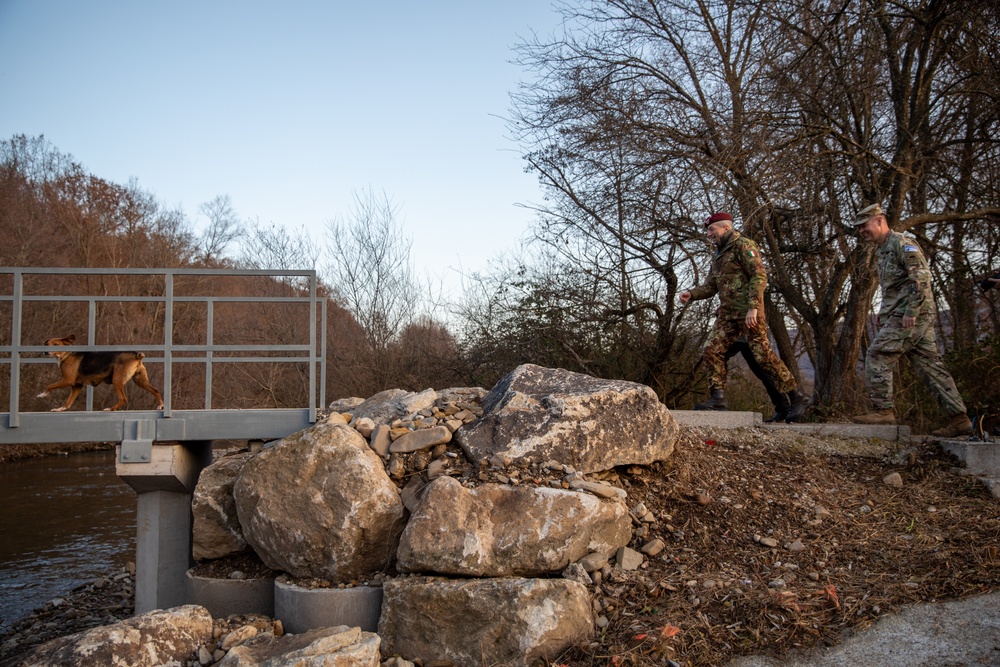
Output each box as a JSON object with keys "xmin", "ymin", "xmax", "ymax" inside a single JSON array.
[{"xmin": 0, "ymin": 268, "xmax": 326, "ymax": 444}]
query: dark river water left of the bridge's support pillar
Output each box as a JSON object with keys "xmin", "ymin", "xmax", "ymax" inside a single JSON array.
[{"xmin": 0, "ymin": 451, "xmax": 136, "ymax": 632}]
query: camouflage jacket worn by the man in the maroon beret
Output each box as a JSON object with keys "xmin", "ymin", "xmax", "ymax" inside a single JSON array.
[{"xmin": 691, "ymin": 229, "xmax": 767, "ymax": 320}]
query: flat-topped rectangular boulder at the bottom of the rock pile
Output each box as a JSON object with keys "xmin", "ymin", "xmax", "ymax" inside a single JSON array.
[{"xmin": 378, "ymin": 577, "xmax": 594, "ymax": 667}]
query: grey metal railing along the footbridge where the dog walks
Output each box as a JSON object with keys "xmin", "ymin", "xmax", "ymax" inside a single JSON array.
[{"xmin": 0, "ymin": 268, "xmax": 327, "ymax": 428}]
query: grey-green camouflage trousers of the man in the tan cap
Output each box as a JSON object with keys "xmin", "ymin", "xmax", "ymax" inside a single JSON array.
[{"xmin": 865, "ymin": 315, "xmax": 965, "ymax": 415}]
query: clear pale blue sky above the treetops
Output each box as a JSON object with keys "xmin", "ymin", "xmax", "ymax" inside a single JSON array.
[{"xmin": 0, "ymin": 0, "xmax": 559, "ymax": 294}]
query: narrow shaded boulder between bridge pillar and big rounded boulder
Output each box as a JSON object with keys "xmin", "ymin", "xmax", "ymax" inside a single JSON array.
[{"xmin": 191, "ymin": 452, "xmax": 253, "ymax": 560}]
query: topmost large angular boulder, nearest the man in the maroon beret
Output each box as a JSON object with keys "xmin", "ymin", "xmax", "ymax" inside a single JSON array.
[{"xmin": 455, "ymin": 364, "xmax": 678, "ymax": 473}]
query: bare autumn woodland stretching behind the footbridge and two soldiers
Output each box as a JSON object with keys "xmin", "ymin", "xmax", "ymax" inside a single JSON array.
[{"xmin": 0, "ymin": 0, "xmax": 1000, "ymax": 426}]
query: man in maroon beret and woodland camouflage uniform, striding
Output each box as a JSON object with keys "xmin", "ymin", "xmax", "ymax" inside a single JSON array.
[{"xmin": 680, "ymin": 213, "xmax": 806, "ymax": 422}]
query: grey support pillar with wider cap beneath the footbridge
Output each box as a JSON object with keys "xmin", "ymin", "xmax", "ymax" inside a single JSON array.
[{"xmin": 115, "ymin": 439, "xmax": 212, "ymax": 614}]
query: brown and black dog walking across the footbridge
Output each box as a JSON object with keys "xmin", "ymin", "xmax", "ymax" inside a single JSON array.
[{"xmin": 38, "ymin": 335, "xmax": 163, "ymax": 412}]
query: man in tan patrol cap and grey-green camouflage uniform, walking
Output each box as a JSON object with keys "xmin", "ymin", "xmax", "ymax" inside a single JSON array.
[{"xmin": 854, "ymin": 204, "xmax": 972, "ymax": 438}]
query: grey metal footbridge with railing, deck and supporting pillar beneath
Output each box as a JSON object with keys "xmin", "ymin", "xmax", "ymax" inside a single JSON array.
[{"xmin": 0, "ymin": 268, "xmax": 327, "ymax": 613}]
